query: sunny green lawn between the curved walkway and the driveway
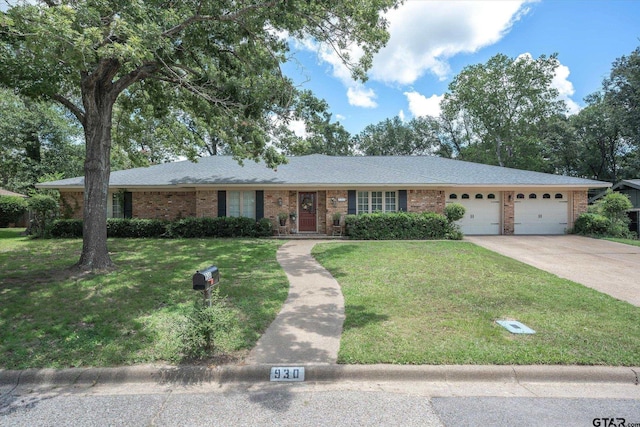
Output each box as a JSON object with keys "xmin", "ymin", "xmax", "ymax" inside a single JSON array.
[{"xmin": 313, "ymin": 242, "xmax": 640, "ymax": 366}]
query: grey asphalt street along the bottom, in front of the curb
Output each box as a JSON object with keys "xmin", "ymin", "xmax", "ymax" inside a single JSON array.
[{"xmin": 0, "ymin": 381, "xmax": 640, "ymax": 426}]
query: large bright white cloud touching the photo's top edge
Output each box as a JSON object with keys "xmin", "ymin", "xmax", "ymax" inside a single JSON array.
[{"xmin": 371, "ymin": 0, "xmax": 530, "ymax": 84}]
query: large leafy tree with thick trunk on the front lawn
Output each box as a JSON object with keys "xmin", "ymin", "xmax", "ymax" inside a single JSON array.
[{"xmin": 0, "ymin": 0, "xmax": 394, "ymax": 269}]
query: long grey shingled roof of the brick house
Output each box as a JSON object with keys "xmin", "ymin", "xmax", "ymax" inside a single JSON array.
[{"xmin": 38, "ymin": 154, "xmax": 610, "ymax": 189}]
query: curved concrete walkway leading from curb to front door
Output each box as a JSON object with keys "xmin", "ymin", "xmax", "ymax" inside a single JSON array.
[{"xmin": 247, "ymin": 240, "xmax": 344, "ymax": 365}]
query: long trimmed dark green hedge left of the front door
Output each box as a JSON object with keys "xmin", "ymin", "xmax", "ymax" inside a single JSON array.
[{"xmin": 51, "ymin": 217, "xmax": 273, "ymax": 238}]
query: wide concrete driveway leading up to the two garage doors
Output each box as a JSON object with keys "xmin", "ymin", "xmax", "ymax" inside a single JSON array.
[{"xmin": 465, "ymin": 235, "xmax": 640, "ymax": 307}]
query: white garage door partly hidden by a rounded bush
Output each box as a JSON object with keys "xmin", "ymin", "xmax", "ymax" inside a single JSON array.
[{"xmin": 447, "ymin": 191, "xmax": 500, "ymax": 235}]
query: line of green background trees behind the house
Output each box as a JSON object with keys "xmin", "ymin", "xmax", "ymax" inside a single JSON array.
[{"xmin": 0, "ymin": 47, "xmax": 640, "ymax": 197}]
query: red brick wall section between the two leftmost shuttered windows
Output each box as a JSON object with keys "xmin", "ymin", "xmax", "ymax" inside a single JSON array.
[{"xmin": 132, "ymin": 191, "xmax": 195, "ymax": 220}]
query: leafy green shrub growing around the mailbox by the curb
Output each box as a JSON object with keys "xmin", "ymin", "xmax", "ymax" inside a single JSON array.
[{"xmin": 179, "ymin": 287, "xmax": 244, "ymax": 360}]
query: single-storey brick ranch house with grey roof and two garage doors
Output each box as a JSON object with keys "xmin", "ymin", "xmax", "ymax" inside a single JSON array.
[{"xmin": 37, "ymin": 154, "xmax": 610, "ymax": 235}]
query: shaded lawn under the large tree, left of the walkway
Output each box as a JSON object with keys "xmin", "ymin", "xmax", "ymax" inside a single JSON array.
[{"xmin": 0, "ymin": 236, "xmax": 288, "ymax": 369}]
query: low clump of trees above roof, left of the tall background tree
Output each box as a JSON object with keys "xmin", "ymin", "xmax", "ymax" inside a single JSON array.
[{"xmin": 354, "ymin": 116, "xmax": 440, "ymax": 156}]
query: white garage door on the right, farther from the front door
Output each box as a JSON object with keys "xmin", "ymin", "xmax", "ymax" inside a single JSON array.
[{"xmin": 514, "ymin": 192, "xmax": 569, "ymax": 234}]
